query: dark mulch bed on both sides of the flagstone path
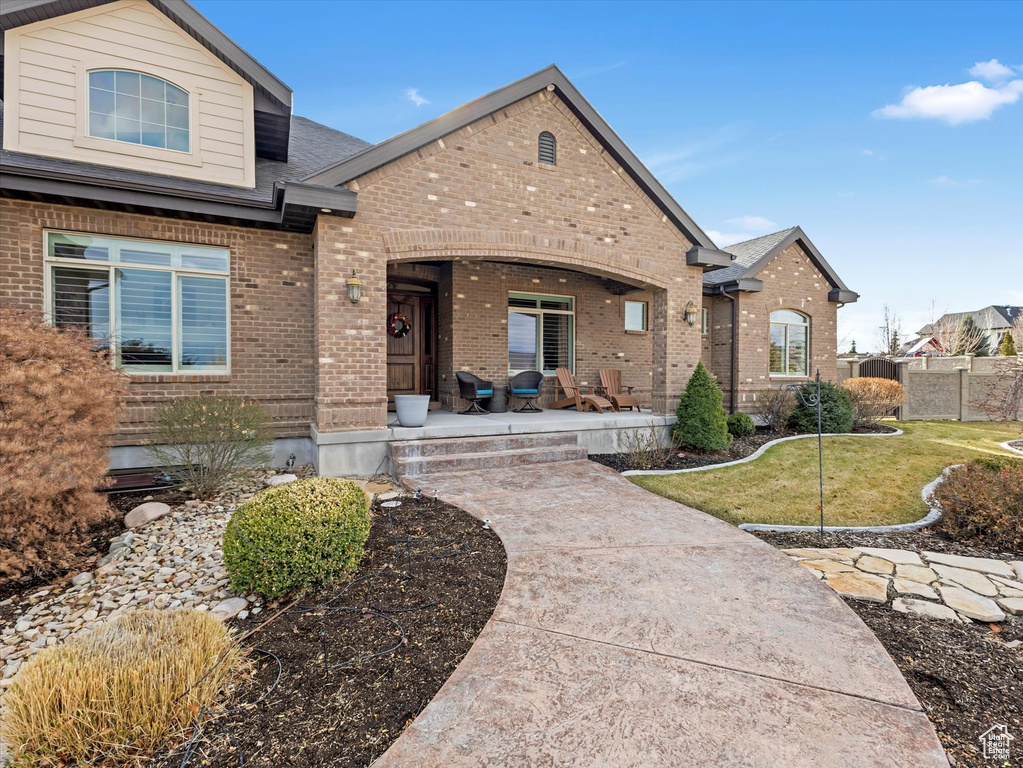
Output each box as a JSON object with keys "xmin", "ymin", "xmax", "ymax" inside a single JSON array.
[{"xmin": 755, "ymin": 529, "xmax": 1023, "ymax": 768}]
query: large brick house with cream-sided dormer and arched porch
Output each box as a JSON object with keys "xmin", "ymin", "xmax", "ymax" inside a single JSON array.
[{"xmin": 0, "ymin": 0, "xmax": 856, "ymax": 472}]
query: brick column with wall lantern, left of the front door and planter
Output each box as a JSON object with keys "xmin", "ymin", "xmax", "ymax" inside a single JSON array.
[{"xmin": 313, "ymin": 216, "xmax": 387, "ymax": 433}]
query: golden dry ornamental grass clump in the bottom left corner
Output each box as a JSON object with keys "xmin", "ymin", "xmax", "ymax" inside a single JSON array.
[{"xmin": 3, "ymin": 611, "xmax": 241, "ymax": 768}]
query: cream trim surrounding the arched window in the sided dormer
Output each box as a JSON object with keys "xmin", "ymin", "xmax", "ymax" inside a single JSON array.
[{"xmin": 72, "ymin": 65, "xmax": 203, "ymax": 167}]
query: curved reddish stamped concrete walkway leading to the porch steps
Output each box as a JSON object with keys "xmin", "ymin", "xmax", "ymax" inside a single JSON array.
[{"xmin": 373, "ymin": 461, "xmax": 948, "ymax": 768}]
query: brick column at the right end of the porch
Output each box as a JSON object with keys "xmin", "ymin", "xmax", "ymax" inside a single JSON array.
[{"xmin": 650, "ymin": 285, "xmax": 702, "ymax": 415}]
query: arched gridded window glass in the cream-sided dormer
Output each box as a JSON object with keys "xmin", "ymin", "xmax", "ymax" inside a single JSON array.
[{"xmin": 89, "ymin": 70, "xmax": 190, "ymax": 152}]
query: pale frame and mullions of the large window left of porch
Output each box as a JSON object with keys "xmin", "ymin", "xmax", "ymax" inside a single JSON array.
[{"xmin": 43, "ymin": 229, "xmax": 231, "ymax": 376}]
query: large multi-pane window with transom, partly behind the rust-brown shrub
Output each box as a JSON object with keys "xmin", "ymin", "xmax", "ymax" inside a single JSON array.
[{"xmin": 46, "ymin": 232, "xmax": 230, "ymax": 373}]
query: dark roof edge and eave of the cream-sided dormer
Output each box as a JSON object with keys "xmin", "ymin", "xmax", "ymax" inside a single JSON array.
[{"xmin": 0, "ymin": 0, "xmax": 292, "ymax": 161}]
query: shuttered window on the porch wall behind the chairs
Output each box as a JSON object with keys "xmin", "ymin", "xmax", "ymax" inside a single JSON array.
[{"xmin": 508, "ymin": 293, "xmax": 575, "ymax": 376}]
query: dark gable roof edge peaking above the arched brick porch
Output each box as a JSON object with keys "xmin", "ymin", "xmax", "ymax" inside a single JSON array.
[{"xmin": 305, "ymin": 64, "xmax": 716, "ymax": 249}]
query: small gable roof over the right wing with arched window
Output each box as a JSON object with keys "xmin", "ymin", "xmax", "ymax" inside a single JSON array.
[{"xmin": 704, "ymin": 227, "xmax": 859, "ymax": 304}]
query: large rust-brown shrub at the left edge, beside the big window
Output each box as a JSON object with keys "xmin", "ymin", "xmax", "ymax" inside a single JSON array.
[{"xmin": 0, "ymin": 310, "xmax": 126, "ymax": 578}]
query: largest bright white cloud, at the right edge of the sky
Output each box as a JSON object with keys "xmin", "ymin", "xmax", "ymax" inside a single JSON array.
[{"xmin": 874, "ymin": 80, "xmax": 1023, "ymax": 126}]
